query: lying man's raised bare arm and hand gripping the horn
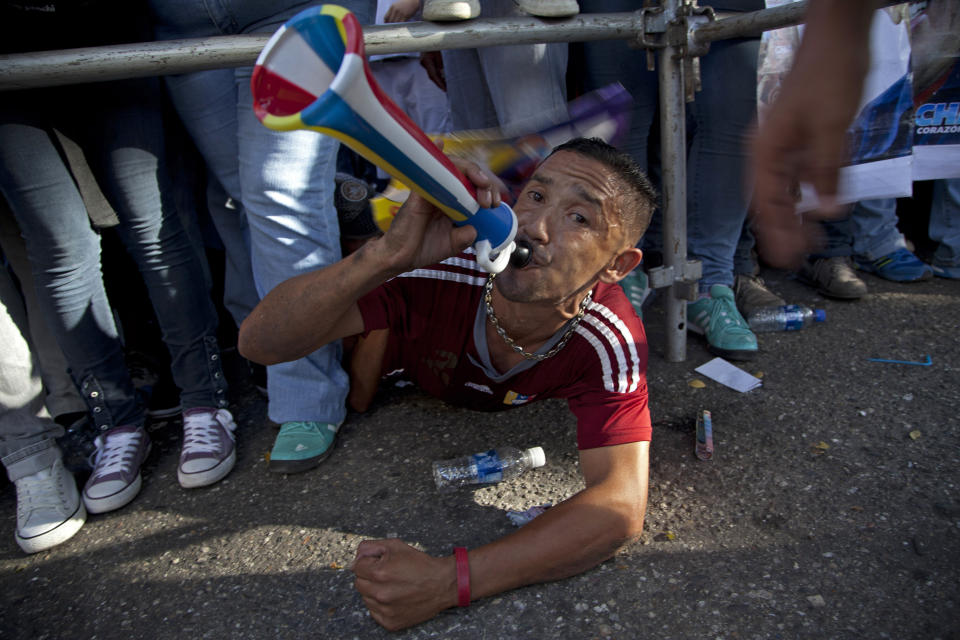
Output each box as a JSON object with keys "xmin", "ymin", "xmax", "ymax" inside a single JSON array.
[{"xmin": 237, "ymin": 163, "xmax": 500, "ymax": 365}]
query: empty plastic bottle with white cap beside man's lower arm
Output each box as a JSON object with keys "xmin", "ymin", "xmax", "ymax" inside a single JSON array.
[{"xmin": 433, "ymin": 447, "xmax": 547, "ymax": 491}]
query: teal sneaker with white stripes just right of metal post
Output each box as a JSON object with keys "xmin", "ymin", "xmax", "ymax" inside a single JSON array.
[{"xmin": 687, "ymin": 284, "xmax": 757, "ymax": 360}]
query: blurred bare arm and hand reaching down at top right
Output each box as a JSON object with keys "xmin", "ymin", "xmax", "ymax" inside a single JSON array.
[{"xmin": 753, "ymin": 0, "xmax": 883, "ymax": 266}]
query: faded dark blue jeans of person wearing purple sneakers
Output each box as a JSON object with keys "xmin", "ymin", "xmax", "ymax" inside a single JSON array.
[{"xmin": 0, "ymin": 79, "xmax": 227, "ymax": 430}]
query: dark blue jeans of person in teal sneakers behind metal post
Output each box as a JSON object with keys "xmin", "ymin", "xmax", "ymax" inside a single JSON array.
[{"xmin": 580, "ymin": 0, "xmax": 760, "ymax": 291}]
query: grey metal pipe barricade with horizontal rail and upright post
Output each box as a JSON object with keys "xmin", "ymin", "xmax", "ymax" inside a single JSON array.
[{"xmin": 0, "ymin": 0, "xmax": 824, "ymax": 362}]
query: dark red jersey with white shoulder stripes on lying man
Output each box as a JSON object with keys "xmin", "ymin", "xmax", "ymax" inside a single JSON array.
[{"xmin": 358, "ymin": 252, "xmax": 651, "ymax": 449}]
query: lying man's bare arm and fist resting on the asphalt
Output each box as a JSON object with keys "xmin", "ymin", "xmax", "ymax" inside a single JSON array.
[{"xmin": 353, "ymin": 442, "xmax": 650, "ymax": 630}]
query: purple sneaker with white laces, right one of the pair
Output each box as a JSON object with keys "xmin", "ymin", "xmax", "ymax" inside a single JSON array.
[{"xmin": 177, "ymin": 407, "xmax": 237, "ymax": 489}]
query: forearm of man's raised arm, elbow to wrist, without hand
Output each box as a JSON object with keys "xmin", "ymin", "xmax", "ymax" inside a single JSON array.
[{"xmin": 238, "ymin": 240, "xmax": 402, "ymax": 364}]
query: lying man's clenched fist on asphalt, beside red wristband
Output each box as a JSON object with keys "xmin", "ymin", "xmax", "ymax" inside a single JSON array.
[{"xmin": 352, "ymin": 539, "xmax": 457, "ymax": 631}]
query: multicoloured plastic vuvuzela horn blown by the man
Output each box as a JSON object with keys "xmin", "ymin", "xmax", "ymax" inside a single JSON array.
[{"xmin": 251, "ymin": 5, "xmax": 517, "ymax": 273}]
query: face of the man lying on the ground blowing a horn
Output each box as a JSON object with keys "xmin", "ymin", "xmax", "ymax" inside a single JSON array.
[{"xmin": 497, "ymin": 151, "xmax": 628, "ymax": 304}]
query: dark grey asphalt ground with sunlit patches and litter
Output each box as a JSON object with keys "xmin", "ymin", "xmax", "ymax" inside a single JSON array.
[{"xmin": 0, "ymin": 262, "xmax": 960, "ymax": 640}]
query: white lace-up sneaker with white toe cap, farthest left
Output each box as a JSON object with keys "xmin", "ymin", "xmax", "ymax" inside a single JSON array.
[{"xmin": 15, "ymin": 459, "xmax": 87, "ymax": 553}]
